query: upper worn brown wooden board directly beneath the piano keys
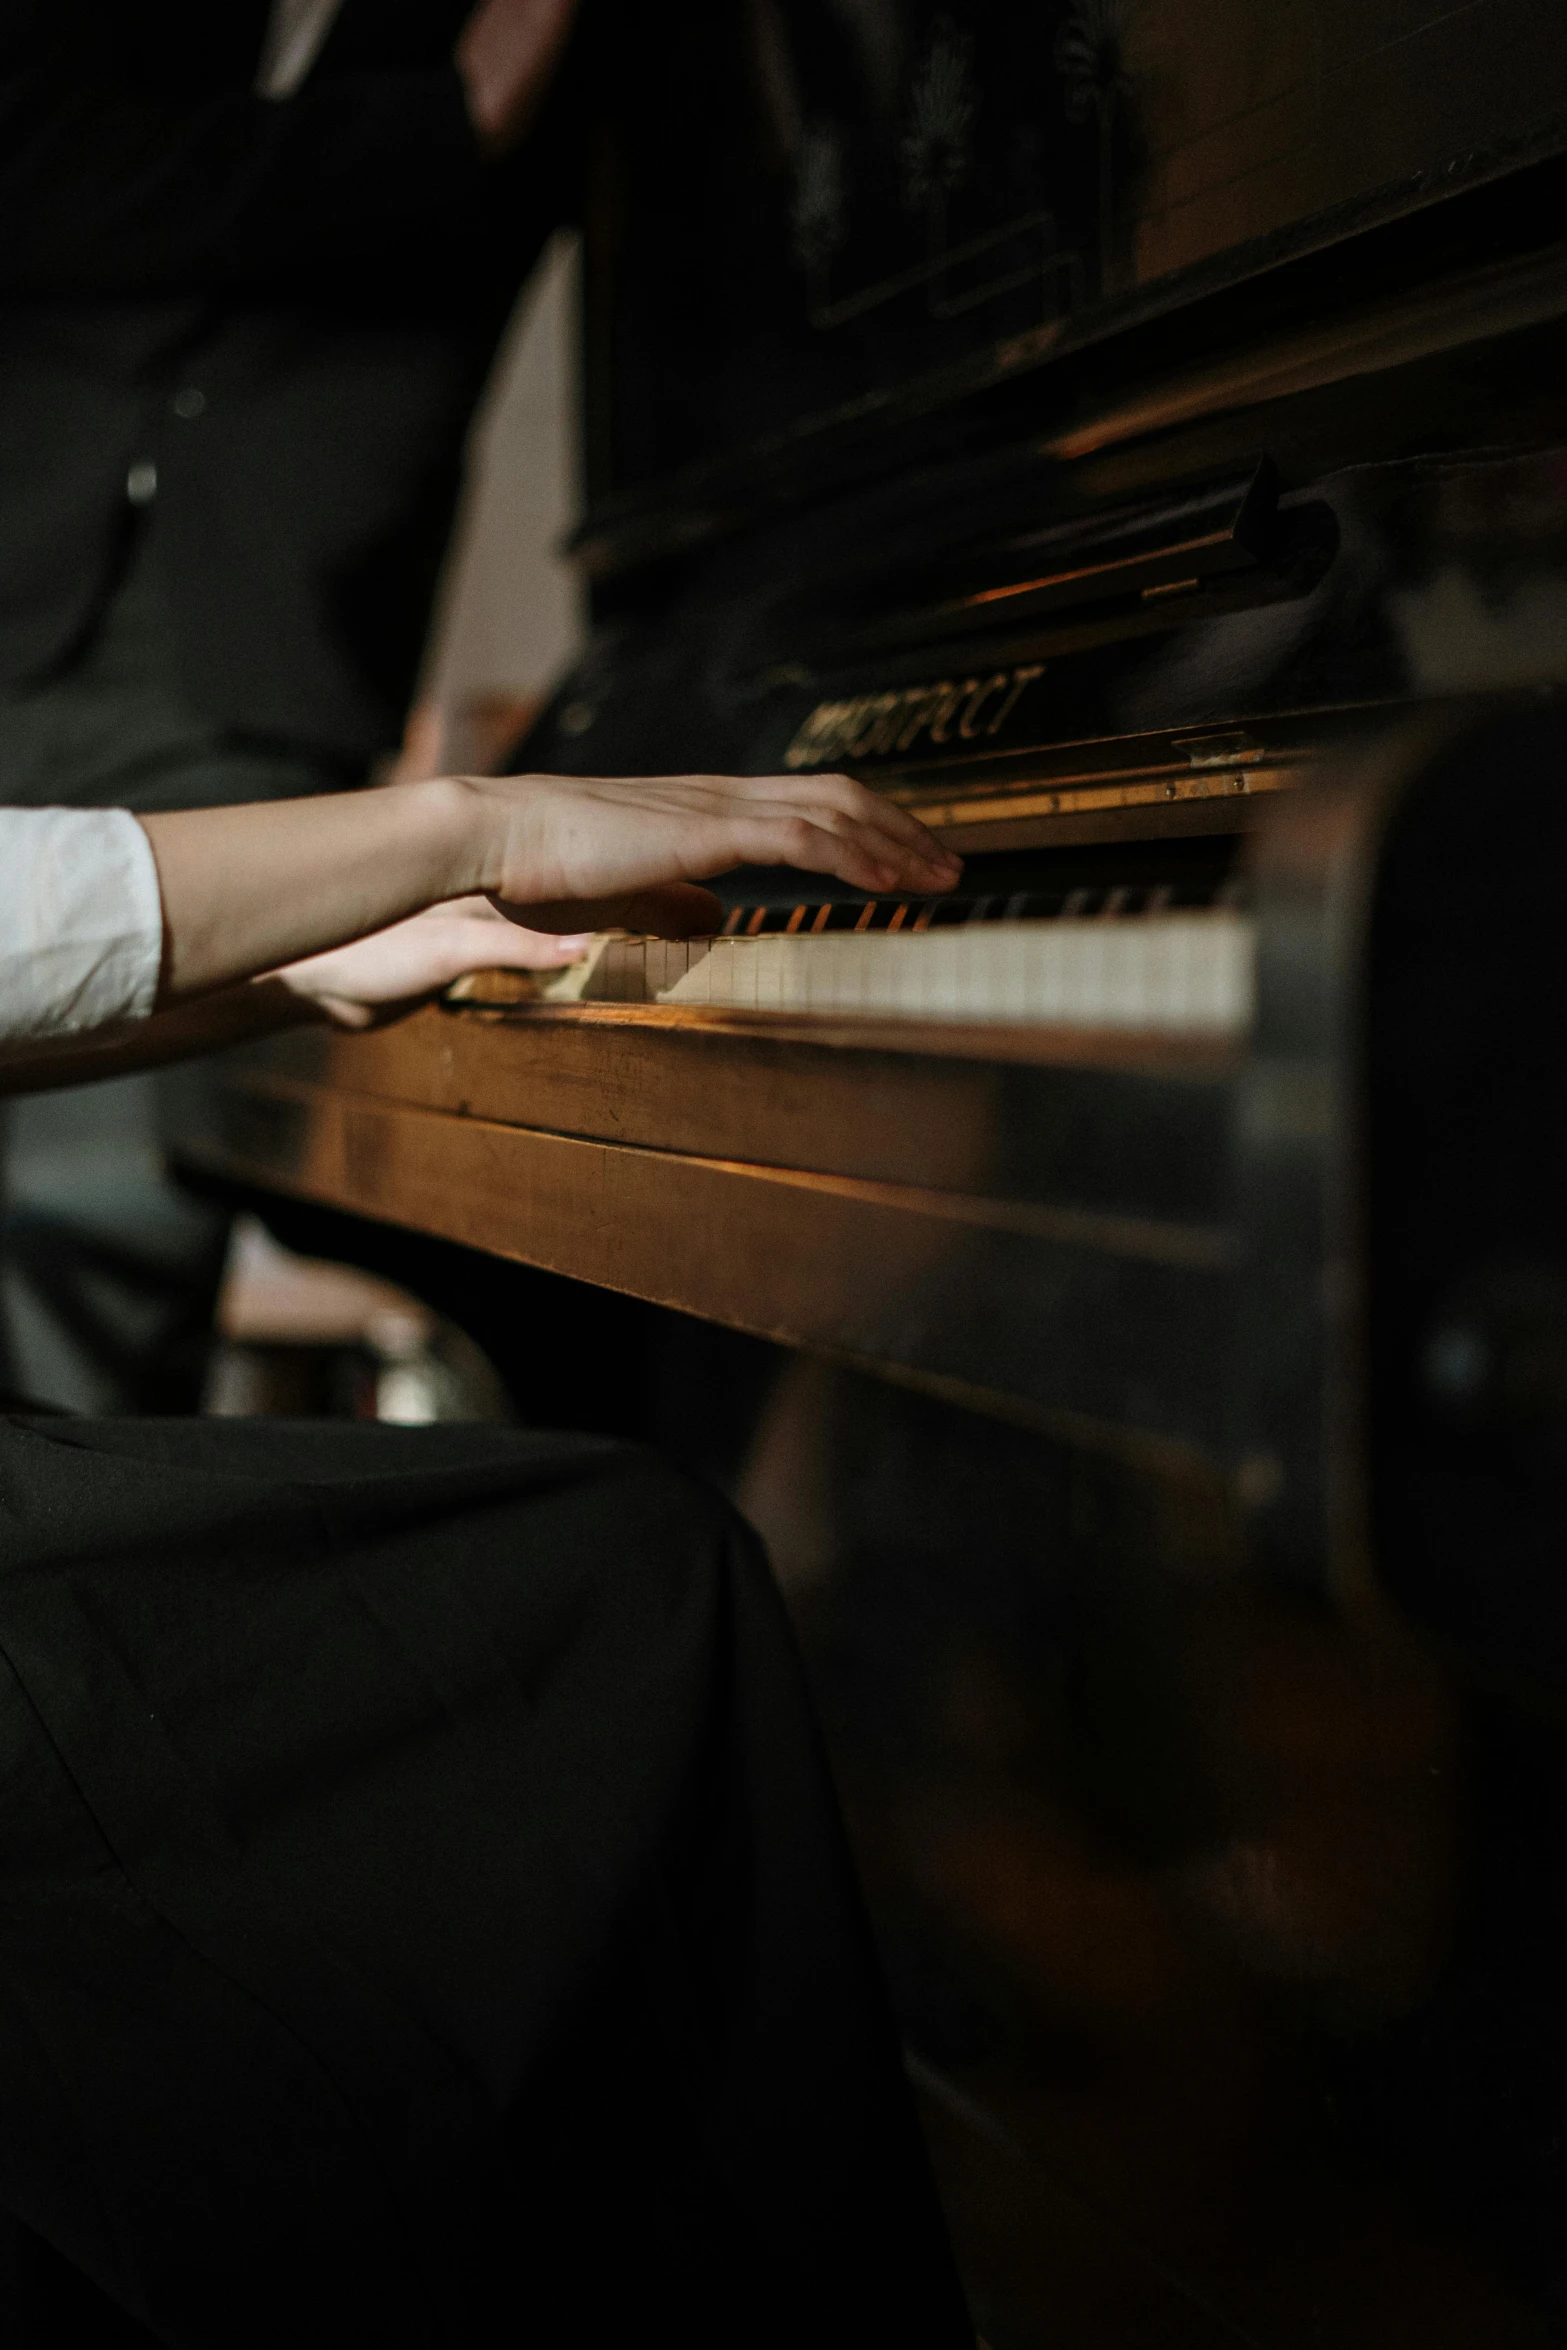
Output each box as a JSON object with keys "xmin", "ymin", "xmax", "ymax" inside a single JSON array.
[{"xmin": 223, "ymin": 1003, "xmax": 1238, "ymax": 1246}]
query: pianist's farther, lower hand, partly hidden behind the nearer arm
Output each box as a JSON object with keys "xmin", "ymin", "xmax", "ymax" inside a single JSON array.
[{"xmin": 270, "ymin": 898, "xmax": 587, "ymax": 1029}]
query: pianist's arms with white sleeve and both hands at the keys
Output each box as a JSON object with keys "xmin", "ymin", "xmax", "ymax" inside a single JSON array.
[{"xmin": 0, "ymin": 776, "xmax": 959, "ymax": 1090}]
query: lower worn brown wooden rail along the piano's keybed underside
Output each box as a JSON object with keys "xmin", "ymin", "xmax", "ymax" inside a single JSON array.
[{"xmin": 183, "ymin": 1062, "xmax": 1233, "ymax": 1466}]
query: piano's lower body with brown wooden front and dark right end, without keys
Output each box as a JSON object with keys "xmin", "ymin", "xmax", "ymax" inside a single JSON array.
[{"xmin": 188, "ymin": 707, "xmax": 1567, "ymax": 2350}]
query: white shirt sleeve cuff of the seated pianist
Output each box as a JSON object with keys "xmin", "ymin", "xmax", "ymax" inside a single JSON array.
[{"xmin": 0, "ymin": 808, "xmax": 162, "ymax": 1041}]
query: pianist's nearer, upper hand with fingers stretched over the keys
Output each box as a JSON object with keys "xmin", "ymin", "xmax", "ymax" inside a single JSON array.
[{"xmin": 463, "ymin": 776, "xmax": 963, "ymax": 938}]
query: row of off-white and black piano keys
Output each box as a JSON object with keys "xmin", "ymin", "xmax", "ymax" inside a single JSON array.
[{"xmin": 451, "ymin": 891, "xmax": 1252, "ymax": 1036}]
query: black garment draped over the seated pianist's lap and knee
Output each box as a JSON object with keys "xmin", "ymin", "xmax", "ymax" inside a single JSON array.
[{"xmin": 0, "ymin": 1419, "xmax": 973, "ymax": 2350}]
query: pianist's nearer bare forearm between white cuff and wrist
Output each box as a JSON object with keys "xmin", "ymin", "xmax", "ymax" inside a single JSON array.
[{"xmin": 141, "ymin": 778, "xmax": 493, "ymax": 1008}]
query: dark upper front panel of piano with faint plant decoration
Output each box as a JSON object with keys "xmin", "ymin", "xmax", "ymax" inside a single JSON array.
[{"xmin": 570, "ymin": 0, "xmax": 1567, "ymax": 538}]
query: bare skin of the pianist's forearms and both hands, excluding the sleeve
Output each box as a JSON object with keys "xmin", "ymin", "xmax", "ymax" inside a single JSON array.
[{"xmin": 141, "ymin": 776, "xmax": 963, "ymax": 1020}]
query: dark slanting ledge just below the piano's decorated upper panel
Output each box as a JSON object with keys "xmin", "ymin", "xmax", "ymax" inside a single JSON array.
[{"xmin": 571, "ymin": 51, "xmax": 1567, "ymax": 583}]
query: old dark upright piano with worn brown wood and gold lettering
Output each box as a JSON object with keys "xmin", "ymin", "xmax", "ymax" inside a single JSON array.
[{"xmin": 179, "ymin": 0, "xmax": 1567, "ymax": 2350}]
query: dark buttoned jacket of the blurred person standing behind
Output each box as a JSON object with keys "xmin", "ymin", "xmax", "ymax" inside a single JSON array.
[{"xmin": 0, "ymin": 0, "xmax": 571, "ymax": 761}]
